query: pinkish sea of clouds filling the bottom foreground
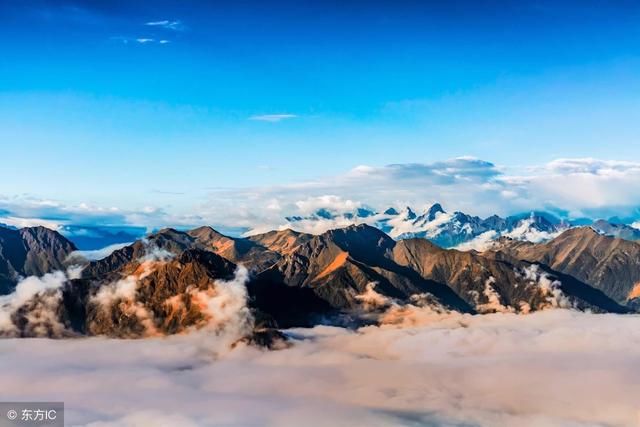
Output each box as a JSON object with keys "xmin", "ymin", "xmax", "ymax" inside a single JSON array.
[{"xmin": 0, "ymin": 310, "xmax": 640, "ymax": 427}]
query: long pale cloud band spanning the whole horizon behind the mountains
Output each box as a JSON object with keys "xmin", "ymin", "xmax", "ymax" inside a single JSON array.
[{"xmin": 0, "ymin": 157, "xmax": 640, "ymax": 237}]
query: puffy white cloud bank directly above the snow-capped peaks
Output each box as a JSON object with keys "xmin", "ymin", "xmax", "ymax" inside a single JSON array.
[{"xmin": 228, "ymin": 157, "xmax": 640, "ymax": 236}]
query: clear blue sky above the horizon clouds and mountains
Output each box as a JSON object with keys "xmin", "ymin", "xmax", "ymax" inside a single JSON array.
[{"xmin": 0, "ymin": 0, "xmax": 640, "ymax": 236}]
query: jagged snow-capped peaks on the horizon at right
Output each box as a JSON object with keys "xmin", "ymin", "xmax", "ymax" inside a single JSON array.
[{"xmin": 286, "ymin": 203, "xmax": 640, "ymax": 249}]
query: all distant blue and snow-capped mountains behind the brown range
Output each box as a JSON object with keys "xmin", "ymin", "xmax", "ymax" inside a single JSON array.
[{"xmin": 5, "ymin": 203, "xmax": 640, "ymax": 254}]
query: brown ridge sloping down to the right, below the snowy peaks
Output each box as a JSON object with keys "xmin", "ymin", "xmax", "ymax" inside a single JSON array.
[{"xmin": 393, "ymin": 239, "xmax": 627, "ymax": 313}]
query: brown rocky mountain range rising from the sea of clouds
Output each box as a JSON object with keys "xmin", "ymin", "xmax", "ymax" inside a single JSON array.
[{"xmin": 0, "ymin": 221, "xmax": 640, "ymax": 340}]
